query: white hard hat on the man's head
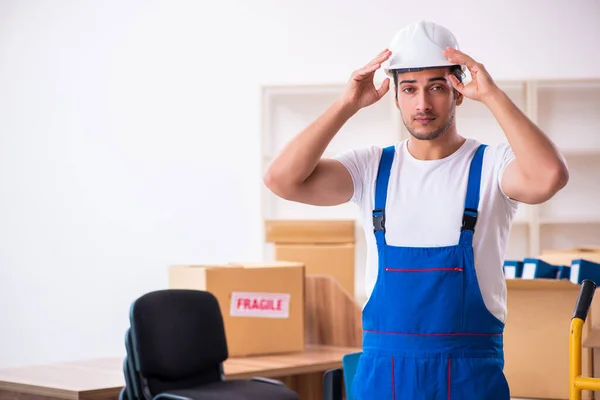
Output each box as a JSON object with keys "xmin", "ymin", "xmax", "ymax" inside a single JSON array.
[{"xmin": 384, "ymin": 21, "xmax": 458, "ymax": 76}]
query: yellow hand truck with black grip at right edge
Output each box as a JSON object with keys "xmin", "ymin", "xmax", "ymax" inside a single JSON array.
[{"xmin": 569, "ymin": 279, "xmax": 600, "ymax": 400}]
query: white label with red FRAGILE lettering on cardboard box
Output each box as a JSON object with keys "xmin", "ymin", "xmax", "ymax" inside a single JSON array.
[{"xmin": 230, "ymin": 292, "xmax": 290, "ymax": 318}]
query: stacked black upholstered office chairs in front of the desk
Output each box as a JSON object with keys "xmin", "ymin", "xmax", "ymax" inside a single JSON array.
[{"xmin": 124, "ymin": 289, "xmax": 299, "ymax": 400}]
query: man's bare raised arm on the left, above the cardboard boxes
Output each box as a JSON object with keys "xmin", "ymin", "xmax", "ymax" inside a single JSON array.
[{"xmin": 264, "ymin": 49, "xmax": 391, "ymax": 206}]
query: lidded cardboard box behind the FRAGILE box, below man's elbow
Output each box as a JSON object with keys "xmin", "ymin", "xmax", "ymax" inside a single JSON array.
[{"xmin": 265, "ymin": 220, "xmax": 356, "ymax": 298}]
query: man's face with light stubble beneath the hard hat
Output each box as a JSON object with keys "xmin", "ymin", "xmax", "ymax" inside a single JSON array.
[{"xmin": 396, "ymin": 68, "xmax": 462, "ymax": 140}]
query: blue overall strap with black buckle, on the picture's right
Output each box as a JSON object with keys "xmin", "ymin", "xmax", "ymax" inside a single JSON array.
[{"xmin": 459, "ymin": 144, "xmax": 487, "ymax": 246}]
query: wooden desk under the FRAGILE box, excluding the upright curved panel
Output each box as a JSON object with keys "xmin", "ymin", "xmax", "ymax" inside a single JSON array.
[{"xmin": 0, "ymin": 345, "xmax": 359, "ymax": 400}]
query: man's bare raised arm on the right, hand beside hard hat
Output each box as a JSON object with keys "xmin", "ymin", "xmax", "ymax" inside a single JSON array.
[{"xmin": 444, "ymin": 49, "xmax": 569, "ymax": 204}]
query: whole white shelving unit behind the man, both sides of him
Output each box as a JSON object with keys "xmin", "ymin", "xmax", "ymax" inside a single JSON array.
[{"xmin": 261, "ymin": 79, "xmax": 600, "ymax": 290}]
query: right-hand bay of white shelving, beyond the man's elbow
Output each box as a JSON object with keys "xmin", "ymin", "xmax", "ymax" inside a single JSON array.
[{"xmin": 535, "ymin": 80, "xmax": 600, "ymax": 256}]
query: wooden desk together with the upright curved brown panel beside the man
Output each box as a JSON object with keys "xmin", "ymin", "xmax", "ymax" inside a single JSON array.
[{"xmin": 0, "ymin": 276, "xmax": 362, "ymax": 400}]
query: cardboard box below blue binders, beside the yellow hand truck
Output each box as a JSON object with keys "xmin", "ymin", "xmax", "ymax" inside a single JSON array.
[{"xmin": 504, "ymin": 279, "xmax": 595, "ymax": 399}]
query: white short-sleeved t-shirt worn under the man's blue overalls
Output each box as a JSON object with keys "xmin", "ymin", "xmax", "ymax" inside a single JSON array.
[{"xmin": 335, "ymin": 139, "xmax": 518, "ymax": 322}]
